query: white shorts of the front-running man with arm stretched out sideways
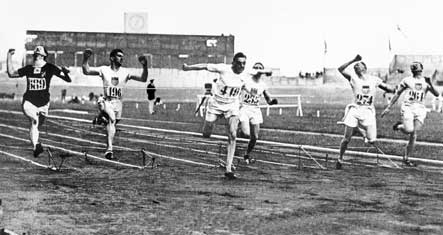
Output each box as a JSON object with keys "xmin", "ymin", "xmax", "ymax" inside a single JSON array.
[{"xmin": 205, "ymin": 98, "xmax": 240, "ymax": 122}]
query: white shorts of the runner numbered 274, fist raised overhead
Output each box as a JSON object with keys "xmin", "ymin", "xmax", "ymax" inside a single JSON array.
[{"xmin": 343, "ymin": 104, "xmax": 377, "ymax": 142}]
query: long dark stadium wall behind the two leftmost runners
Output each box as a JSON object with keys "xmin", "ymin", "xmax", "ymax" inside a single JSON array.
[{"xmin": 25, "ymin": 30, "xmax": 235, "ymax": 69}]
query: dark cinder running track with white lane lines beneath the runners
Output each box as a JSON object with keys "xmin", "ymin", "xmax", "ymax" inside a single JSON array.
[{"xmin": 0, "ymin": 103, "xmax": 443, "ymax": 234}]
